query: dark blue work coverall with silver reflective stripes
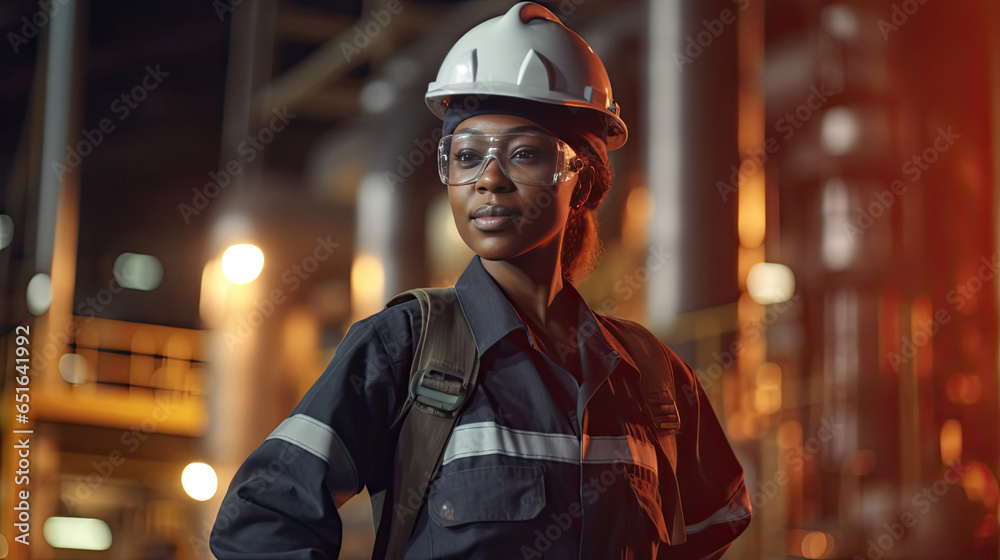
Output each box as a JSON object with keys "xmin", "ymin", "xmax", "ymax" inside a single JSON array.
[{"xmin": 210, "ymin": 257, "xmax": 750, "ymax": 560}]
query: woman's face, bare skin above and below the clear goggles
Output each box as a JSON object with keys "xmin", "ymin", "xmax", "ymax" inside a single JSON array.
[{"xmin": 448, "ymin": 115, "xmax": 577, "ymax": 260}]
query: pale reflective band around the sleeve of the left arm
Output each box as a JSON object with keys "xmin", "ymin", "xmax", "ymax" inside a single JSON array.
[{"xmin": 267, "ymin": 414, "xmax": 361, "ymax": 494}]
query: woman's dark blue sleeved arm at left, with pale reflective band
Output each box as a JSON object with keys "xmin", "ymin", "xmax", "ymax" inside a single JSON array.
[{"xmin": 210, "ymin": 303, "xmax": 420, "ymax": 560}]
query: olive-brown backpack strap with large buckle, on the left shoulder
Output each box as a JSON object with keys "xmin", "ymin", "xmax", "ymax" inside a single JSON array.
[{"xmin": 372, "ymin": 288, "xmax": 479, "ymax": 560}]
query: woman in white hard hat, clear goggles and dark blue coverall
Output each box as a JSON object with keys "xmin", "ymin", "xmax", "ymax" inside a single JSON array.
[{"xmin": 211, "ymin": 2, "xmax": 750, "ymax": 560}]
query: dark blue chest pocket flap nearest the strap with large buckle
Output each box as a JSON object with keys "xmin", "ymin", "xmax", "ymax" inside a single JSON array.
[{"xmin": 427, "ymin": 465, "xmax": 545, "ymax": 527}]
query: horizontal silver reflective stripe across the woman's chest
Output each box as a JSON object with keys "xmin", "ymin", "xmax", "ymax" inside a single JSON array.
[{"xmin": 441, "ymin": 422, "xmax": 656, "ymax": 470}]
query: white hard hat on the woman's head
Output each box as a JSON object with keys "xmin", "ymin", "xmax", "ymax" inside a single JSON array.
[{"xmin": 425, "ymin": 2, "xmax": 628, "ymax": 150}]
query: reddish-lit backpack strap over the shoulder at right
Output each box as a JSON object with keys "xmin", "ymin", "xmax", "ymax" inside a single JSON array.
[{"xmin": 595, "ymin": 314, "xmax": 687, "ymax": 546}]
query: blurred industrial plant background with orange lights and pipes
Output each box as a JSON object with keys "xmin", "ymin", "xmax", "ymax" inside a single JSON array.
[{"xmin": 0, "ymin": 0, "xmax": 1000, "ymax": 560}]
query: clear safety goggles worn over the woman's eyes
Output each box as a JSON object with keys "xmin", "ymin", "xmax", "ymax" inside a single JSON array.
[{"xmin": 438, "ymin": 132, "xmax": 583, "ymax": 186}]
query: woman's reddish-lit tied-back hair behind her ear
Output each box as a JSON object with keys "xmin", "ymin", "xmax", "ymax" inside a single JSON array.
[{"xmin": 560, "ymin": 146, "xmax": 612, "ymax": 282}]
